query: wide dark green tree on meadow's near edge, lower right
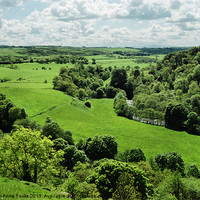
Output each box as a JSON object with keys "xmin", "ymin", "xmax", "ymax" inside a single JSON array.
[{"xmin": 155, "ymin": 152, "xmax": 185, "ymax": 174}]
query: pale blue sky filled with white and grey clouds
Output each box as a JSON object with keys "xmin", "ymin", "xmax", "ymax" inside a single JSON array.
[{"xmin": 0, "ymin": 0, "xmax": 200, "ymax": 47}]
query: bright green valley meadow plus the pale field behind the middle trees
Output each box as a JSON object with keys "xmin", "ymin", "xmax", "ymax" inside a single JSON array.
[{"xmin": 0, "ymin": 49, "xmax": 200, "ymax": 167}]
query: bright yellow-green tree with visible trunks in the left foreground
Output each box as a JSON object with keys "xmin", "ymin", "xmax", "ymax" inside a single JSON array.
[{"xmin": 0, "ymin": 128, "xmax": 63, "ymax": 182}]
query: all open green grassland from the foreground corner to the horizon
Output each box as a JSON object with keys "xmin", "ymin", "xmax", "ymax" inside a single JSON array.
[{"xmin": 0, "ymin": 46, "xmax": 200, "ymax": 199}]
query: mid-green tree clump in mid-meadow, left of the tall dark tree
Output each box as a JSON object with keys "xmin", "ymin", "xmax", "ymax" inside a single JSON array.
[{"xmin": 53, "ymin": 65, "xmax": 110, "ymax": 100}]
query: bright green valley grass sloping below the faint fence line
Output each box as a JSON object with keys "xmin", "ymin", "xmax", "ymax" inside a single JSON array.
[{"xmin": 0, "ymin": 83, "xmax": 200, "ymax": 166}]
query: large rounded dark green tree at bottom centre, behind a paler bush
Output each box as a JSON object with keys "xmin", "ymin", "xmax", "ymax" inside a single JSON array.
[{"xmin": 87, "ymin": 160, "xmax": 150, "ymax": 199}]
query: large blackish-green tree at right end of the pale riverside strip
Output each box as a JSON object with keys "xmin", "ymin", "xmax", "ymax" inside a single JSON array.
[{"xmin": 165, "ymin": 104, "xmax": 188, "ymax": 130}]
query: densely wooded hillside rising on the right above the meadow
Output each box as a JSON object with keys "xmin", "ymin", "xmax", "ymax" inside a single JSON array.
[{"xmin": 111, "ymin": 47, "xmax": 200, "ymax": 135}]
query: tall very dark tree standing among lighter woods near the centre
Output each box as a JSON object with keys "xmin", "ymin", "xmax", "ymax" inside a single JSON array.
[{"xmin": 110, "ymin": 68, "xmax": 127, "ymax": 89}]
